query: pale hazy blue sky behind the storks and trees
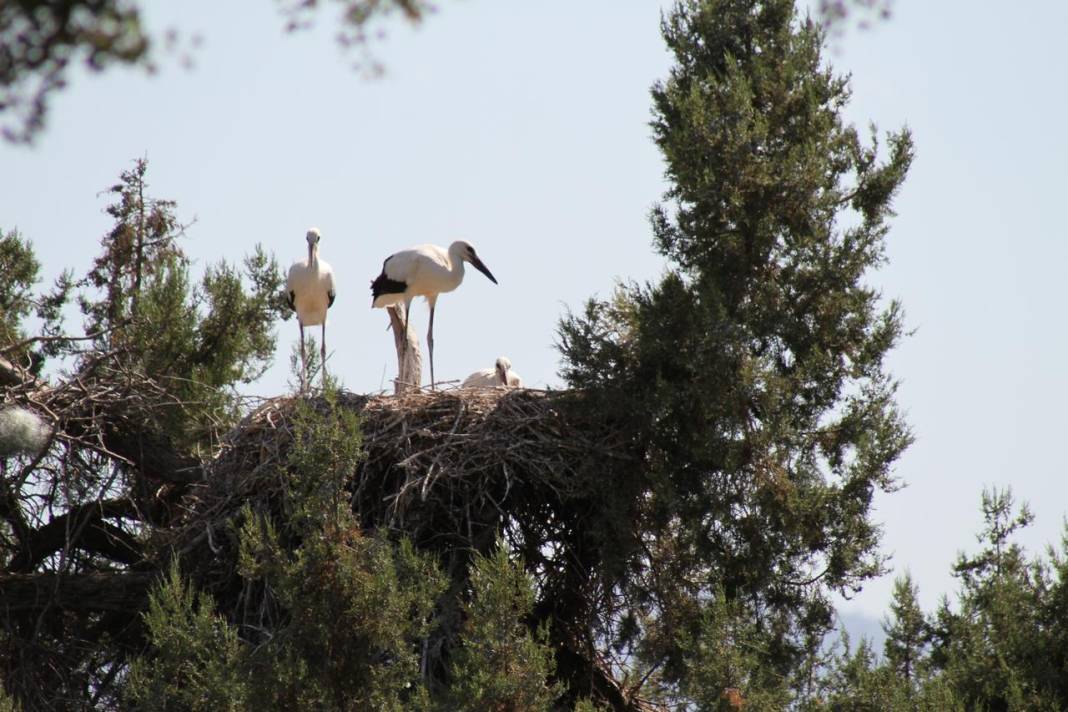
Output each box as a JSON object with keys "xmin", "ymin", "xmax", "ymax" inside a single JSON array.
[{"xmin": 6, "ymin": 0, "xmax": 1068, "ymax": 627}]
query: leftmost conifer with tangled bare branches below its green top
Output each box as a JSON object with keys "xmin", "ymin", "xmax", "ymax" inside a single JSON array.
[{"xmin": 0, "ymin": 161, "xmax": 282, "ymax": 710}]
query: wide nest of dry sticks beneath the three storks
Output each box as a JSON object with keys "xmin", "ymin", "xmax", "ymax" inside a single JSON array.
[{"xmin": 165, "ymin": 390, "xmax": 622, "ymax": 551}]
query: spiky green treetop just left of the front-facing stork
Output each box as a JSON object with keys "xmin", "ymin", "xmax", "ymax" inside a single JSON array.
[{"xmin": 77, "ymin": 159, "xmax": 288, "ymax": 445}]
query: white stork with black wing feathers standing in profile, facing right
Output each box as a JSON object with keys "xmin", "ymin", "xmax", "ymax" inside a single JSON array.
[{"xmin": 371, "ymin": 240, "xmax": 497, "ymax": 389}]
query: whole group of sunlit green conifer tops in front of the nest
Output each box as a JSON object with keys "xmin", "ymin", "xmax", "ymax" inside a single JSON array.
[{"xmin": 126, "ymin": 392, "xmax": 561, "ymax": 712}]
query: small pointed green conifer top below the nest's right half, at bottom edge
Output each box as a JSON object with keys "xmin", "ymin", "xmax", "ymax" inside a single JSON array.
[{"xmin": 441, "ymin": 542, "xmax": 562, "ymax": 712}]
